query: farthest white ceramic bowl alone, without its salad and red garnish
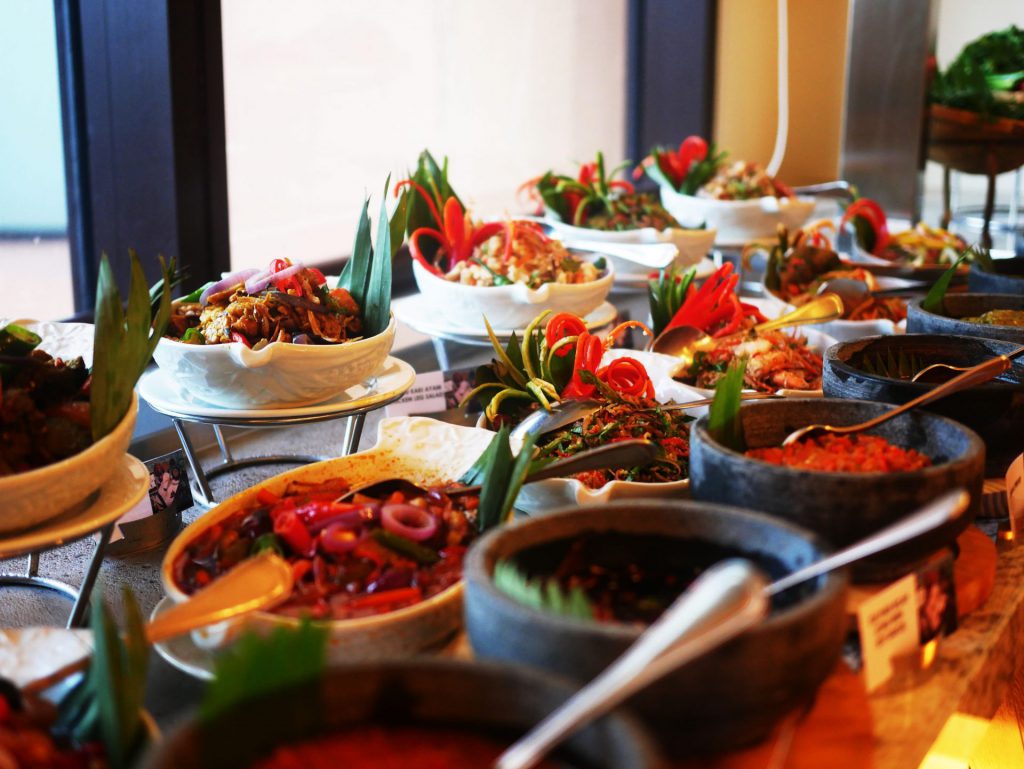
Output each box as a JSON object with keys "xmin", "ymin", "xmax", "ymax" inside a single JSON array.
[{"xmin": 660, "ymin": 184, "xmax": 814, "ymax": 246}]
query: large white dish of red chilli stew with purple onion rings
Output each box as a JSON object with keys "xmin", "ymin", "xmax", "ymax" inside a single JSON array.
[{"xmin": 161, "ymin": 418, "xmax": 505, "ymax": 660}]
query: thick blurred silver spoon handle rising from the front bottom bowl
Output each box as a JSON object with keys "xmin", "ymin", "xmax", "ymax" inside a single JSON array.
[{"xmin": 495, "ymin": 559, "xmax": 769, "ymax": 769}]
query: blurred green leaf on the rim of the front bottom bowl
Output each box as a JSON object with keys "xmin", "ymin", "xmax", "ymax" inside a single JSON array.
[{"xmin": 199, "ymin": 620, "xmax": 328, "ymax": 723}]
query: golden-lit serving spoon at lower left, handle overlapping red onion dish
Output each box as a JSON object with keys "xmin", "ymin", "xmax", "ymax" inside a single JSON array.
[{"xmin": 24, "ymin": 552, "xmax": 294, "ymax": 694}]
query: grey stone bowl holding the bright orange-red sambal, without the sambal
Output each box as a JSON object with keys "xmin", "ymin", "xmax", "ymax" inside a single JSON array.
[{"xmin": 690, "ymin": 398, "xmax": 985, "ymax": 582}]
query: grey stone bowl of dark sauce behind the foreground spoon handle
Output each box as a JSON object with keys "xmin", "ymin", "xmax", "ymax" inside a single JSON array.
[{"xmin": 466, "ymin": 500, "xmax": 847, "ymax": 757}]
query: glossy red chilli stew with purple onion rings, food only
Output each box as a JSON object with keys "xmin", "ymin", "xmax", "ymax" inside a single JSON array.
[{"xmin": 174, "ymin": 479, "xmax": 479, "ymax": 620}]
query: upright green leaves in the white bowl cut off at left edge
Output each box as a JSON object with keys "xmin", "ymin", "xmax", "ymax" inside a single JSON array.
[{"xmin": 90, "ymin": 251, "xmax": 175, "ymax": 440}]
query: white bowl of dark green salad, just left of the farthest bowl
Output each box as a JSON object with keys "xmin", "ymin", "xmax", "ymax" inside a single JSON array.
[{"xmin": 520, "ymin": 153, "xmax": 715, "ymax": 271}]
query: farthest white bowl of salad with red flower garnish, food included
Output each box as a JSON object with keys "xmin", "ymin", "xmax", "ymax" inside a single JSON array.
[{"xmin": 638, "ymin": 136, "xmax": 814, "ymax": 245}]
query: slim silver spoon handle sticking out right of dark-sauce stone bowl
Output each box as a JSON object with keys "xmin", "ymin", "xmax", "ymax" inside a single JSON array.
[{"xmin": 767, "ymin": 488, "xmax": 971, "ymax": 595}]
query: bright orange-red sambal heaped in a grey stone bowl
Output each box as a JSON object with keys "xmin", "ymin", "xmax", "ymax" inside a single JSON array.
[{"xmin": 746, "ymin": 433, "xmax": 932, "ymax": 473}]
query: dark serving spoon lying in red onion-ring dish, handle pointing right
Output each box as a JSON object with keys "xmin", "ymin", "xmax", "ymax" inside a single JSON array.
[{"xmin": 336, "ymin": 438, "xmax": 662, "ymax": 502}]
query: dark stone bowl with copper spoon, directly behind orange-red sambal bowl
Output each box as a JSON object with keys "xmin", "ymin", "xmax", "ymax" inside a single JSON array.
[{"xmin": 822, "ymin": 334, "xmax": 1024, "ymax": 478}]
